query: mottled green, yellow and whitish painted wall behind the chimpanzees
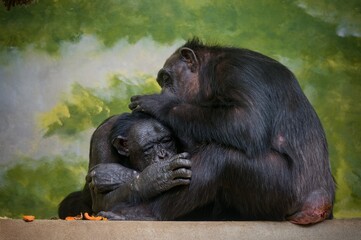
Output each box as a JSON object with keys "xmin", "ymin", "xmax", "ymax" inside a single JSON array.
[{"xmin": 0, "ymin": 0, "xmax": 361, "ymax": 218}]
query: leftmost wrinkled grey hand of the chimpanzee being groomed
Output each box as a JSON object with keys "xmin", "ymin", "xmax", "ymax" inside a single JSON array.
[{"xmin": 86, "ymin": 163, "xmax": 138, "ymax": 193}]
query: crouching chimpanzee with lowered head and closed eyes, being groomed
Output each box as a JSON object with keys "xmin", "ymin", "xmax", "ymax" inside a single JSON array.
[{"xmin": 59, "ymin": 113, "xmax": 191, "ymax": 219}]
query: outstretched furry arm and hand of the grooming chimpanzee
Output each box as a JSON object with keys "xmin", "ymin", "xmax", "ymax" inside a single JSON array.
[{"xmin": 129, "ymin": 93, "xmax": 270, "ymax": 154}]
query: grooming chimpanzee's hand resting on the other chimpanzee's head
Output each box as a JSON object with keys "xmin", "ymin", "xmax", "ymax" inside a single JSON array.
[{"xmin": 129, "ymin": 93, "xmax": 178, "ymax": 116}]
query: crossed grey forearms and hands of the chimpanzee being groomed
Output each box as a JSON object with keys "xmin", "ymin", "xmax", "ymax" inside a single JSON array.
[{"xmin": 87, "ymin": 153, "xmax": 191, "ymax": 212}]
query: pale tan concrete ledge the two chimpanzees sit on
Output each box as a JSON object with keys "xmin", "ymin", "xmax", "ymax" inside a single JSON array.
[{"xmin": 0, "ymin": 219, "xmax": 361, "ymax": 240}]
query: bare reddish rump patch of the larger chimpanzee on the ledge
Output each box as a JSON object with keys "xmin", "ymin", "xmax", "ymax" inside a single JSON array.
[{"xmin": 287, "ymin": 190, "xmax": 332, "ymax": 225}]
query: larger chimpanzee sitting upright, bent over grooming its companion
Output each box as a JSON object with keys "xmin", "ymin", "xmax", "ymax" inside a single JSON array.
[{"xmin": 130, "ymin": 39, "xmax": 335, "ymax": 224}]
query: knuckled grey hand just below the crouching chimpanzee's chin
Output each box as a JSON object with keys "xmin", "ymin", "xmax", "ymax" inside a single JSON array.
[{"xmin": 131, "ymin": 153, "xmax": 192, "ymax": 199}]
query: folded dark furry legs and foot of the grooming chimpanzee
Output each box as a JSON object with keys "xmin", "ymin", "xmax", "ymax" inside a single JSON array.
[{"xmin": 152, "ymin": 144, "xmax": 300, "ymax": 220}]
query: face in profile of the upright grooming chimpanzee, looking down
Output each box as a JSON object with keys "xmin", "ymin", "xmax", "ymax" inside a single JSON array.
[{"xmin": 157, "ymin": 48, "xmax": 199, "ymax": 100}]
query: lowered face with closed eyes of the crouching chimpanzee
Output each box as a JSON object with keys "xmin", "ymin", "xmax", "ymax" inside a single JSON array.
[{"xmin": 128, "ymin": 120, "xmax": 177, "ymax": 171}]
